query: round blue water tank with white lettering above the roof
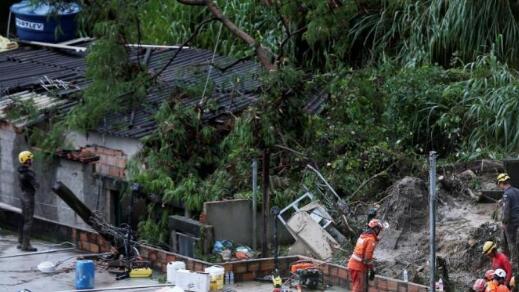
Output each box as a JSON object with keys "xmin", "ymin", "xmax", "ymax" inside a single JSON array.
[{"xmin": 11, "ymin": 1, "xmax": 80, "ymax": 43}]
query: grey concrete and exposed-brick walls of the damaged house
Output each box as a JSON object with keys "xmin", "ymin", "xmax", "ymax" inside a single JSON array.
[{"xmin": 0, "ymin": 124, "xmax": 142, "ymax": 228}]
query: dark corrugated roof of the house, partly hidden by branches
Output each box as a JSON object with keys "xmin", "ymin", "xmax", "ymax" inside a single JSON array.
[{"xmin": 0, "ymin": 47, "xmax": 261, "ymax": 139}]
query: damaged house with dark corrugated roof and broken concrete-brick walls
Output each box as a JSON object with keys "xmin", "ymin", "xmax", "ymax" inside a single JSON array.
[{"xmin": 0, "ymin": 42, "xmax": 260, "ymax": 232}]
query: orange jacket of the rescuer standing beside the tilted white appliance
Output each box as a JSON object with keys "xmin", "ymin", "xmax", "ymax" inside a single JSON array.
[{"xmin": 348, "ymin": 231, "xmax": 378, "ymax": 272}]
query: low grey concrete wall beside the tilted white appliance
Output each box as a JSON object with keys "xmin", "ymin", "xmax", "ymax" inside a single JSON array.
[{"xmin": 204, "ymin": 200, "xmax": 294, "ymax": 249}]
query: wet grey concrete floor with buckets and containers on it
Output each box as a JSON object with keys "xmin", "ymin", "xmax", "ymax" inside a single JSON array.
[{"xmin": 0, "ymin": 230, "xmax": 345, "ymax": 292}]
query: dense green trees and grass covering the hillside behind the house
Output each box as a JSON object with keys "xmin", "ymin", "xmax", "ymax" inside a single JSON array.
[{"xmin": 37, "ymin": 0, "xmax": 519, "ymax": 241}]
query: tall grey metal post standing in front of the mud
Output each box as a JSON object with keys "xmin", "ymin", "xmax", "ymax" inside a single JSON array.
[{"xmin": 429, "ymin": 151, "xmax": 436, "ymax": 291}]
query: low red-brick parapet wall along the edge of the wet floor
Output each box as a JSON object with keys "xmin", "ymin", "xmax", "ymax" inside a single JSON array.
[{"xmin": 0, "ymin": 209, "xmax": 428, "ymax": 292}]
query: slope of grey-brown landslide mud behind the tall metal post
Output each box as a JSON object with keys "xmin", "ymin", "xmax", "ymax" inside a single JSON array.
[{"xmin": 375, "ymin": 173, "xmax": 501, "ymax": 291}]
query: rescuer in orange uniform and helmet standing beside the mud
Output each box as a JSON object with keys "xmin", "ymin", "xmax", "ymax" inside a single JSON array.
[{"xmin": 348, "ymin": 219, "xmax": 384, "ymax": 292}]
